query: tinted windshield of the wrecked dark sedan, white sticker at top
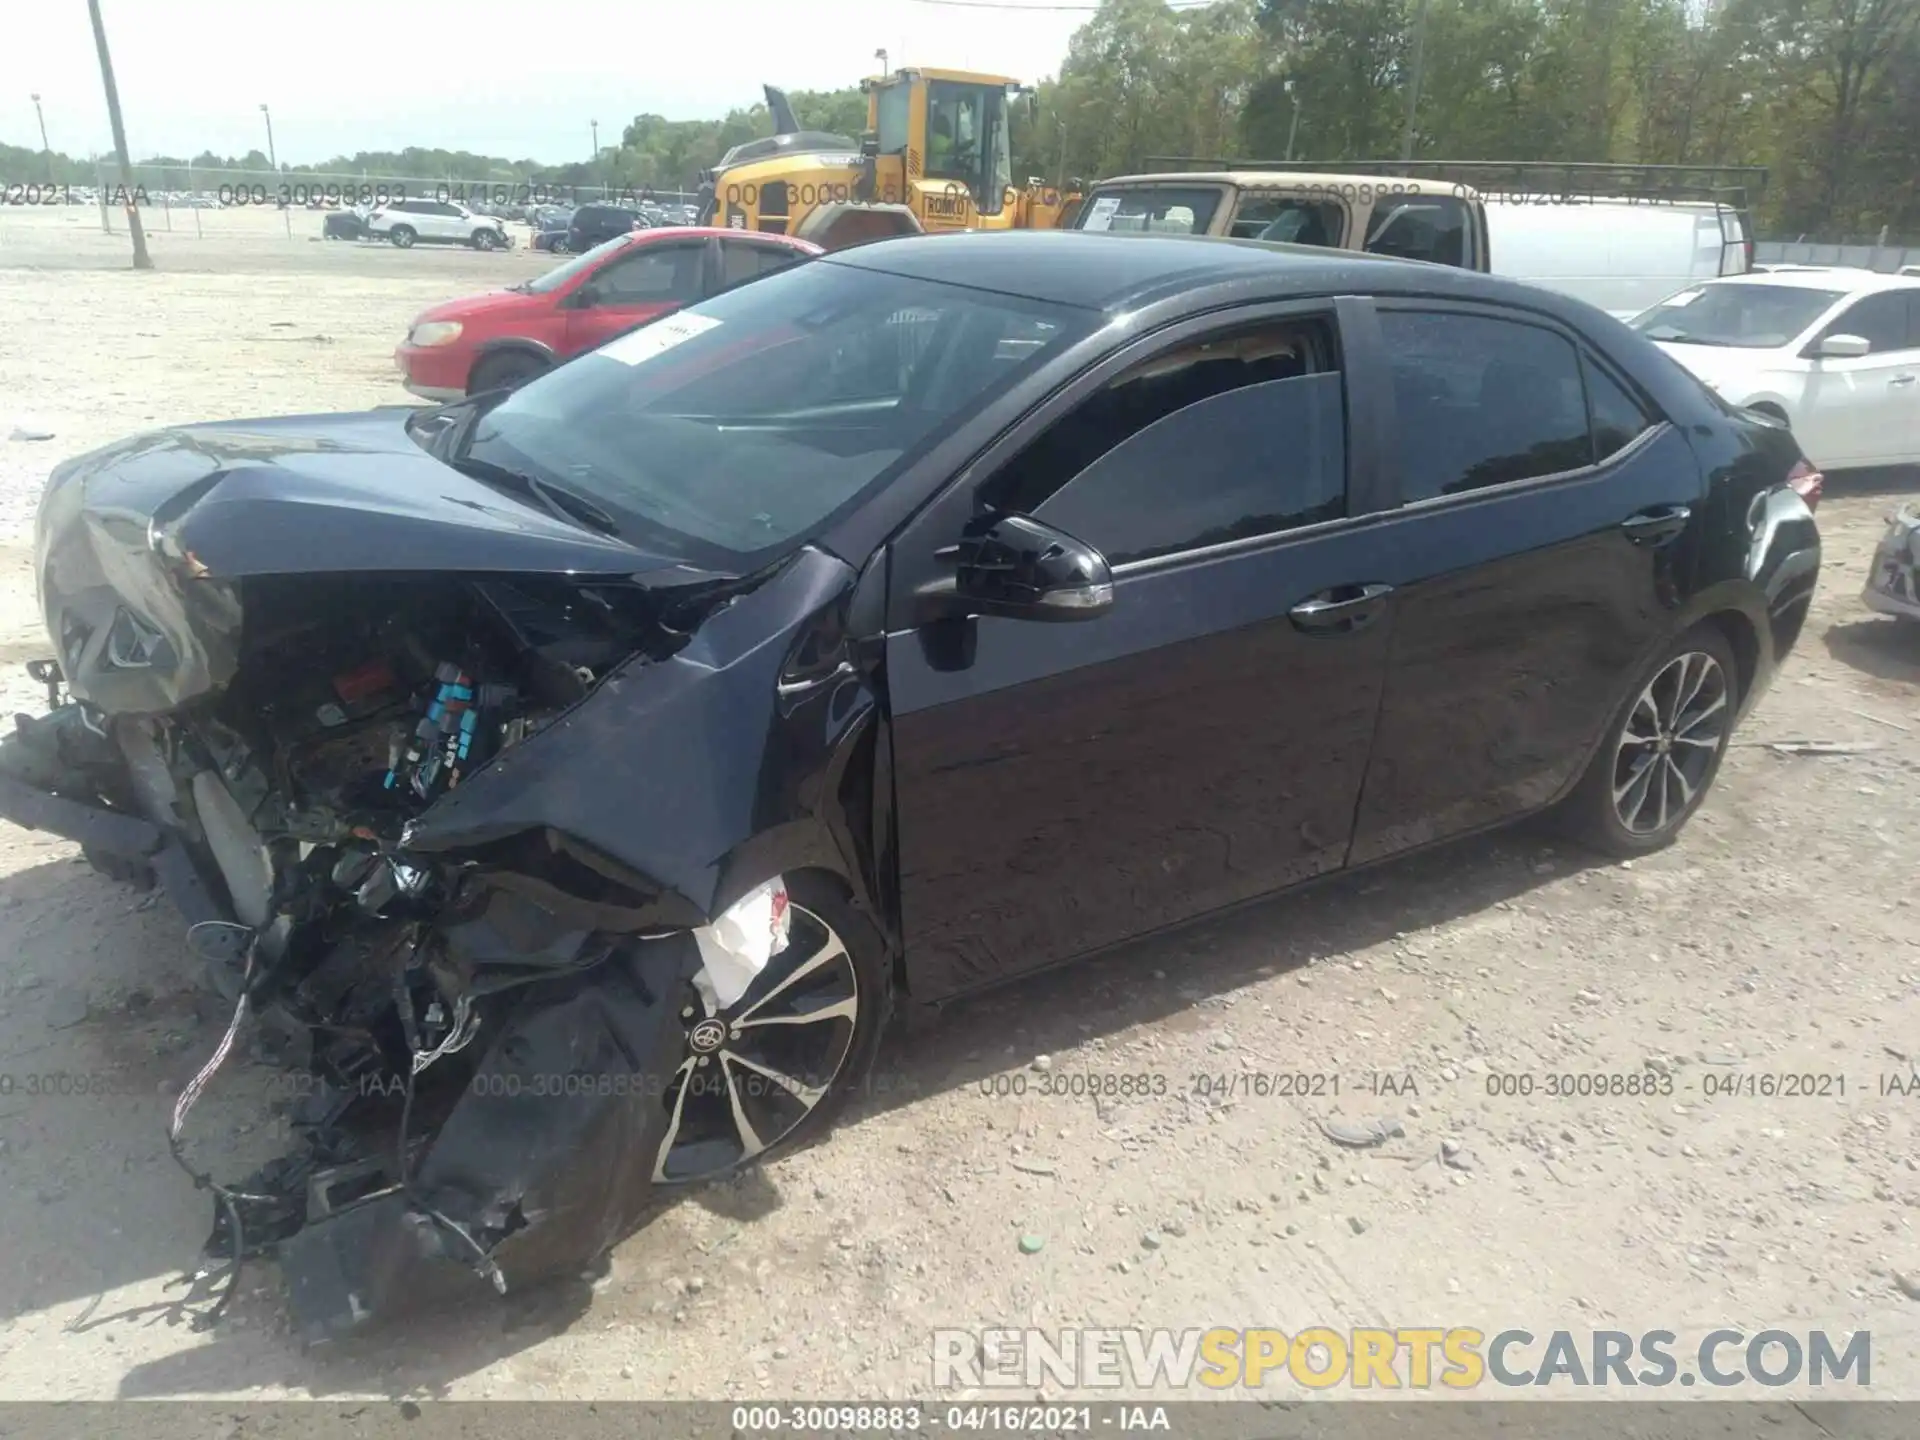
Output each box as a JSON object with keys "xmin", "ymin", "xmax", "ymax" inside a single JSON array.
[{"xmin": 465, "ymin": 261, "xmax": 1098, "ymax": 570}]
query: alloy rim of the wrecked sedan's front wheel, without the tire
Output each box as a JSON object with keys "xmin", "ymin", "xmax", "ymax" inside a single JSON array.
[{"xmin": 653, "ymin": 902, "xmax": 862, "ymax": 1185}]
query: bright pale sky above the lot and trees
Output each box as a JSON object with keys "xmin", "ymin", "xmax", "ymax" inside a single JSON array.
[{"xmin": 0, "ymin": 0, "xmax": 1092, "ymax": 165}]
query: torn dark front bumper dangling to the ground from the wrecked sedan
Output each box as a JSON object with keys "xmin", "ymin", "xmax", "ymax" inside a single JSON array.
[{"xmin": 0, "ymin": 705, "xmax": 701, "ymax": 1342}]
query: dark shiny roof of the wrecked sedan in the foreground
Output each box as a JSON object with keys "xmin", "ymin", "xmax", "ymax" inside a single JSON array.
[{"xmin": 822, "ymin": 230, "xmax": 1528, "ymax": 313}]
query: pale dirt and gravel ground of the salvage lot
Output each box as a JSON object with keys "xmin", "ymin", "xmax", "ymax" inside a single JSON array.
[{"xmin": 0, "ymin": 209, "xmax": 1920, "ymax": 1398}]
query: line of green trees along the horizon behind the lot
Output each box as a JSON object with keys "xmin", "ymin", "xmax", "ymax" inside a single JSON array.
[{"xmin": 0, "ymin": 0, "xmax": 1920, "ymax": 240}]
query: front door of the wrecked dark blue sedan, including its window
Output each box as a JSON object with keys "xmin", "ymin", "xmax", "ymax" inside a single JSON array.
[{"xmin": 887, "ymin": 307, "xmax": 1390, "ymax": 998}]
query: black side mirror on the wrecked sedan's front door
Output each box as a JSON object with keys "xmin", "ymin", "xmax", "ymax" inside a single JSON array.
[{"xmin": 925, "ymin": 515, "xmax": 1114, "ymax": 620}]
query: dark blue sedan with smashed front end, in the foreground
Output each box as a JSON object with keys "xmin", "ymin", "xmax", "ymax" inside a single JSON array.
[{"xmin": 0, "ymin": 232, "xmax": 1820, "ymax": 1334}]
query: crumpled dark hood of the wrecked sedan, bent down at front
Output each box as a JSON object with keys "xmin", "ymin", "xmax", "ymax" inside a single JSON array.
[{"xmin": 35, "ymin": 407, "xmax": 702, "ymax": 714}]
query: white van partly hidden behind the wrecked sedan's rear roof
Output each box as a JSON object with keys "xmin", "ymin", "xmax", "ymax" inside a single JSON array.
[{"xmin": 1482, "ymin": 194, "xmax": 1753, "ymax": 319}]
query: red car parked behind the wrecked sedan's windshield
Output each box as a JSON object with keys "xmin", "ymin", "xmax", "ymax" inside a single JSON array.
[{"xmin": 394, "ymin": 225, "xmax": 820, "ymax": 401}]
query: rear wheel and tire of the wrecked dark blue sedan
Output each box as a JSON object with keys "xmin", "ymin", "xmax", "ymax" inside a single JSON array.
[{"xmin": 1561, "ymin": 624, "xmax": 1740, "ymax": 858}]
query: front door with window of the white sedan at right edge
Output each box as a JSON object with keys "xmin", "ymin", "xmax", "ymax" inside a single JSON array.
[{"xmin": 1793, "ymin": 290, "xmax": 1920, "ymax": 468}]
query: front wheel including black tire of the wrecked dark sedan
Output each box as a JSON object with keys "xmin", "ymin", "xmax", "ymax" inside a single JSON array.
[{"xmin": 653, "ymin": 874, "xmax": 893, "ymax": 1187}]
